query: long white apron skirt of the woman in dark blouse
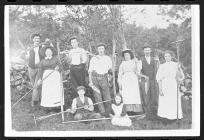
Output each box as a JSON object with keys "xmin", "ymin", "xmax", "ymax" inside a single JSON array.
[{"xmin": 41, "ymin": 70, "xmax": 64, "ymax": 107}]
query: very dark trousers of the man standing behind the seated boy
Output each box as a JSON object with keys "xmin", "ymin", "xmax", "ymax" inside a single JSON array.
[{"xmin": 70, "ymin": 64, "xmax": 85, "ymax": 96}]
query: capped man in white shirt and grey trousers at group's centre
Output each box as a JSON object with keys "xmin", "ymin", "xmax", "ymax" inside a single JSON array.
[{"xmin": 88, "ymin": 43, "xmax": 112, "ymax": 117}]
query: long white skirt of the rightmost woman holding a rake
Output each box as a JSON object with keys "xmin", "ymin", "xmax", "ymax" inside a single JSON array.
[{"xmin": 158, "ymin": 78, "xmax": 183, "ymax": 119}]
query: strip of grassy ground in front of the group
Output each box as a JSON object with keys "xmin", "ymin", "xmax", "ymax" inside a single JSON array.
[{"xmin": 11, "ymin": 87, "xmax": 192, "ymax": 131}]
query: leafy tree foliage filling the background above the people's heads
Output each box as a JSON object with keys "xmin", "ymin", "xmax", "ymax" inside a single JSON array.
[{"xmin": 9, "ymin": 5, "xmax": 191, "ymax": 73}]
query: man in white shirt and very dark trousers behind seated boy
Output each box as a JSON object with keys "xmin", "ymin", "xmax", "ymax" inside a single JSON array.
[{"xmin": 68, "ymin": 36, "xmax": 88, "ymax": 97}]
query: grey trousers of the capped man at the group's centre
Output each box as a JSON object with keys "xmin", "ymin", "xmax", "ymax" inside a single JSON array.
[{"xmin": 92, "ymin": 73, "xmax": 111, "ymax": 114}]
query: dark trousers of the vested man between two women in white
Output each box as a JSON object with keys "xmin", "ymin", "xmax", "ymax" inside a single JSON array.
[{"xmin": 140, "ymin": 79, "xmax": 159, "ymax": 115}]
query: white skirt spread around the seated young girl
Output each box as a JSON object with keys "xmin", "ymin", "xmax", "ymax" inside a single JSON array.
[{"xmin": 111, "ymin": 115, "xmax": 132, "ymax": 126}]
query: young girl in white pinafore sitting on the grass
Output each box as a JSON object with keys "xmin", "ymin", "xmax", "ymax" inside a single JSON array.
[{"xmin": 110, "ymin": 94, "xmax": 132, "ymax": 126}]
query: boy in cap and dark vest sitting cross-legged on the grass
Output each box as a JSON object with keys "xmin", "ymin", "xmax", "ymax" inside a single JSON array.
[{"xmin": 68, "ymin": 86, "xmax": 101, "ymax": 120}]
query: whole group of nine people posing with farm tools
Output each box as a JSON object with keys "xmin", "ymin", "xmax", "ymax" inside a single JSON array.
[{"xmin": 28, "ymin": 34, "xmax": 184, "ymax": 126}]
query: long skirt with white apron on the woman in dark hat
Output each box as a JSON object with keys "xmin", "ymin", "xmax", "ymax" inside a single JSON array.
[{"xmin": 122, "ymin": 72, "xmax": 142, "ymax": 112}]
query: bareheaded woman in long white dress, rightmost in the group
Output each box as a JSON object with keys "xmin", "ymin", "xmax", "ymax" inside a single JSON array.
[{"xmin": 156, "ymin": 51, "xmax": 184, "ymax": 120}]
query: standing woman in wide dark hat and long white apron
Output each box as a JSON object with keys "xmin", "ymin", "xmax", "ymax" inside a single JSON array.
[{"xmin": 118, "ymin": 49, "xmax": 146, "ymax": 115}]
